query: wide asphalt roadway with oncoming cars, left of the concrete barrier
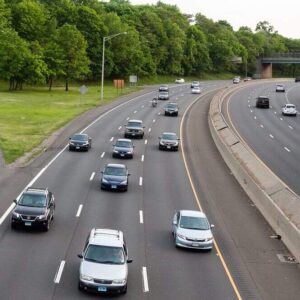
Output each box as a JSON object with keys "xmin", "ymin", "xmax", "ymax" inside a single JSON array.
[{"xmin": 0, "ymin": 81, "xmax": 300, "ymax": 300}]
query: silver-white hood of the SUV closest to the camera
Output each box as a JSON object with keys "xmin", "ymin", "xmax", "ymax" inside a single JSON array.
[{"xmin": 80, "ymin": 260, "xmax": 128, "ymax": 280}]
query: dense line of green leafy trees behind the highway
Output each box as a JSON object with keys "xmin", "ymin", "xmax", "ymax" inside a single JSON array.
[{"xmin": 0, "ymin": 0, "xmax": 300, "ymax": 90}]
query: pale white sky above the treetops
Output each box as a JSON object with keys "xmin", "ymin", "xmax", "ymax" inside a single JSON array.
[{"xmin": 129, "ymin": 0, "xmax": 300, "ymax": 39}]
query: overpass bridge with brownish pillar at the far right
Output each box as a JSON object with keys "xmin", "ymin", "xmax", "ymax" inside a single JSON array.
[{"xmin": 257, "ymin": 52, "xmax": 300, "ymax": 78}]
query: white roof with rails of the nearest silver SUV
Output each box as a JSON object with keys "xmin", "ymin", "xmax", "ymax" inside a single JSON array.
[{"xmin": 89, "ymin": 228, "xmax": 124, "ymax": 247}]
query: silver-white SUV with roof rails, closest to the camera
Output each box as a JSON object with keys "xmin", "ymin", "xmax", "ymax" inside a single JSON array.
[{"xmin": 78, "ymin": 228, "xmax": 132, "ymax": 294}]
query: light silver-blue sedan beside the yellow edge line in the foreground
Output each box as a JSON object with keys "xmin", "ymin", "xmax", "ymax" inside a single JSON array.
[{"xmin": 172, "ymin": 210, "xmax": 214, "ymax": 250}]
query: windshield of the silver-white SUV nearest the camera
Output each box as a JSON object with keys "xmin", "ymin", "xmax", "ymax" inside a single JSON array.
[{"xmin": 84, "ymin": 244, "xmax": 125, "ymax": 265}]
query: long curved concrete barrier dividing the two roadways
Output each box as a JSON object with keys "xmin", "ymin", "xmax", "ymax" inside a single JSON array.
[{"xmin": 208, "ymin": 88, "xmax": 300, "ymax": 262}]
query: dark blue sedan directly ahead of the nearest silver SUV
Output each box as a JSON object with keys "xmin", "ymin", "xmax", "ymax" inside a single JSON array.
[{"xmin": 101, "ymin": 164, "xmax": 130, "ymax": 192}]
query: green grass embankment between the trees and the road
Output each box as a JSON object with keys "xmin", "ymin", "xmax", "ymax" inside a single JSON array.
[{"xmin": 0, "ymin": 74, "xmax": 232, "ymax": 164}]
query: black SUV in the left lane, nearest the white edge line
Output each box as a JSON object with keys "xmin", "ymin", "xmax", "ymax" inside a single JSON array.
[{"xmin": 11, "ymin": 188, "xmax": 55, "ymax": 231}]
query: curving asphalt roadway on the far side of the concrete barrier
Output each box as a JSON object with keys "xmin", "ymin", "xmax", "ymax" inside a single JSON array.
[{"xmin": 228, "ymin": 81, "xmax": 300, "ymax": 195}]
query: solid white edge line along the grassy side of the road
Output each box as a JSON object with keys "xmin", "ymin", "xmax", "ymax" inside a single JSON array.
[{"xmin": 0, "ymin": 92, "xmax": 155, "ymax": 226}]
